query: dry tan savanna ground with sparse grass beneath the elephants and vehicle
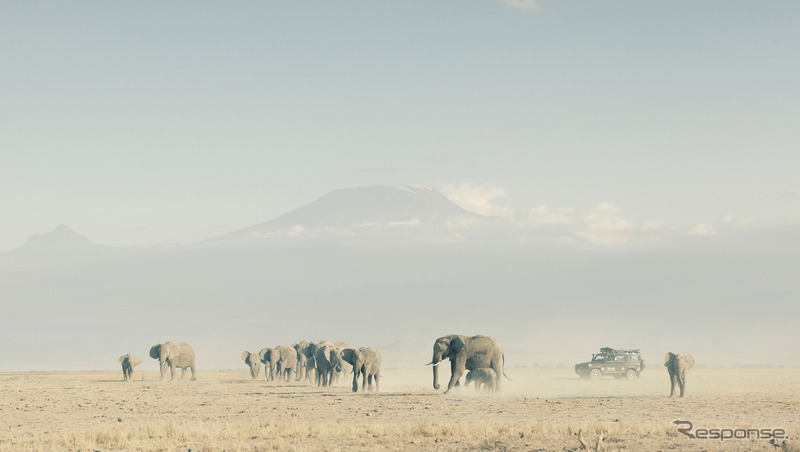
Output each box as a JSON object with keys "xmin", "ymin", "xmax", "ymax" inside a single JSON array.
[{"xmin": 0, "ymin": 366, "xmax": 800, "ymax": 451}]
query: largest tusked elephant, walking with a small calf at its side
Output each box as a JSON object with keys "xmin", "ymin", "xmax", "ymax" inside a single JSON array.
[{"xmin": 427, "ymin": 334, "xmax": 508, "ymax": 394}]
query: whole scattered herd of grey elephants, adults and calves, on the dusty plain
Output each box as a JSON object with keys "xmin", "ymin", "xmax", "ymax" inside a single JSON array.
[{"xmin": 119, "ymin": 334, "xmax": 694, "ymax": 397}]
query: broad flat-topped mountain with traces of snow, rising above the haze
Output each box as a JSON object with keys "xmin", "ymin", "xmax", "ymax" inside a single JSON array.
[{"xmin": 212, "ymin": 186, "xmax": 480, "ymax": 241}]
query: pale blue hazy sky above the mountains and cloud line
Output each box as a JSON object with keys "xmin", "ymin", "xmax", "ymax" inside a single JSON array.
[{"xmin": 0, "ymin": 0, "xmax": 800, "ymax": 251}]
